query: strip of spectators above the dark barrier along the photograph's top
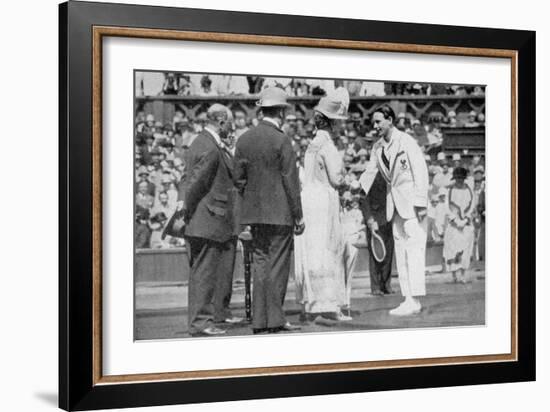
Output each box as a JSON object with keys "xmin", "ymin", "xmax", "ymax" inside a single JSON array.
[{"xmin": 136, "ymin": 72, "xmax": 485, "ymax": 97}]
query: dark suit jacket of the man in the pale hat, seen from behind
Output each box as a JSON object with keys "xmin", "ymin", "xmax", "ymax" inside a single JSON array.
[{"xmin": 235, "ymin": 121, "xmax": 302, "ymax": 226}]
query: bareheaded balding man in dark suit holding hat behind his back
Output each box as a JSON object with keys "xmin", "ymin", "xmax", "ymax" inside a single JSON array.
[{"xmin": 178, "ymin": 104, "xmax": 239, "ymax": 336}]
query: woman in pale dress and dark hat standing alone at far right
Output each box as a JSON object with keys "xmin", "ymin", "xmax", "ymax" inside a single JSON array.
[{"xmin": 443, "ymin": 167, "xmax": 476, "ymax": 283}]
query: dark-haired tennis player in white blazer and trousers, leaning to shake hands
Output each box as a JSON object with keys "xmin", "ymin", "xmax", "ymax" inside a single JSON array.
[{"xmin": 359, "ymin": 106, "xmax": 434, "ymax": 316}]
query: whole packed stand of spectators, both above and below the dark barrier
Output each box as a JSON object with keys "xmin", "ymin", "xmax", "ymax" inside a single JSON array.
[{"xmin": 135, "ymin": 73, "xmax": 485, "ymax": 259}]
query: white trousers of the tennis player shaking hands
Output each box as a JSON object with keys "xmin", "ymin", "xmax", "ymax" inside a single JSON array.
[{"xmin": 392, "ymin": 211, "xmax": 428, "ymax": 297}]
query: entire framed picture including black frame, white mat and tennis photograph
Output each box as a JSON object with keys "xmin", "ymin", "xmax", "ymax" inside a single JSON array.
[{"xmin": 59, "ymin": 1, "xmax": 535, "ymax": 410}]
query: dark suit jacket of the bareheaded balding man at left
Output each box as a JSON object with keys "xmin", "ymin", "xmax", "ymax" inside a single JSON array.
[{"xmin": 178, "ymin": 130, "xmax": 237, "ymax": 242}]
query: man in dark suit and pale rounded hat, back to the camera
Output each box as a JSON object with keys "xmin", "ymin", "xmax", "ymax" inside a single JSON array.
[{"xmin": 235, "ymin": 87, "xmax": 304, "ymax": 333}]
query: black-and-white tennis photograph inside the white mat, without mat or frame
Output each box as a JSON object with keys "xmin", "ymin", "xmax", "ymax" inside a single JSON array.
[{"xmin": 134, "ymin": 68, "xmax": 487, "ymax": 341}]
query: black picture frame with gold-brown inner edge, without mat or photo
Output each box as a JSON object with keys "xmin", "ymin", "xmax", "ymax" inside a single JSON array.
[{"xmin": 59, "ymin": 2, "xmax": 535, "ymax": 410}]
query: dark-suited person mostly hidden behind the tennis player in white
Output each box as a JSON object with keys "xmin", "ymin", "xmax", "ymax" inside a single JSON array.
[{"xmin": 360, "ymin": 172, "xmax": 394, "ymax": 296}]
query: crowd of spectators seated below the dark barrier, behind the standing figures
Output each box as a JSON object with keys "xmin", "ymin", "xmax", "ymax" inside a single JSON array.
[{"xmin": 135, "ymin": 76, "xmax": 485, "ymax": 248}]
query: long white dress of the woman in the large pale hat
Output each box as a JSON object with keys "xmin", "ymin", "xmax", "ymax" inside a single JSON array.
[{"xmin": 294, "ymin": 130, "xmax": 357, "ymax": 313}]
